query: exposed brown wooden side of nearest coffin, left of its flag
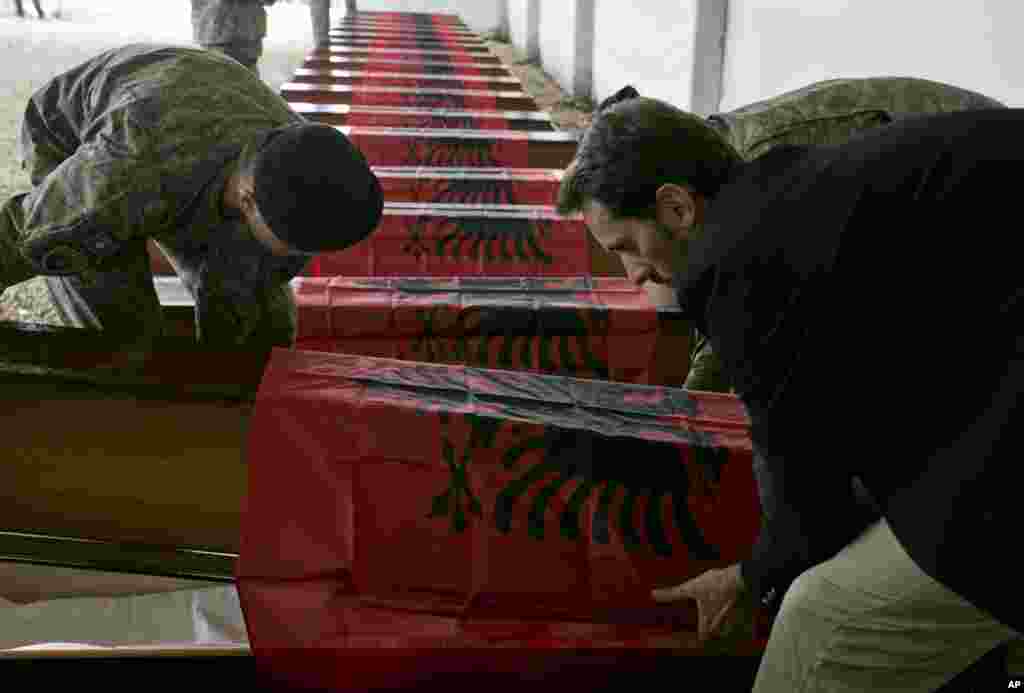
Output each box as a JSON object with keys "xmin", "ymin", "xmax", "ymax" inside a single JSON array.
[{"xmin": 0, "ymin": 322, "xmax": 266, "ymax": 579}]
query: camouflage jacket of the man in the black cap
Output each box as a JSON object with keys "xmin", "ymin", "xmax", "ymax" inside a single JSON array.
[{"xmin": 0, "ymin": 44, "xmax": 306, "ymax": 344}]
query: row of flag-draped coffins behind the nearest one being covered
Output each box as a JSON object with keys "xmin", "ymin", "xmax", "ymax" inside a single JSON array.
[{"xmin": 157, "ymin": 9, "xmax": 688, "ymax": 378}]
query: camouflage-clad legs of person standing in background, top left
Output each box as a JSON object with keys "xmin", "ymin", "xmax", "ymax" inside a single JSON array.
[{"xmin": 191, "ymin": 0, "xmax": 276, "ymax": 72}]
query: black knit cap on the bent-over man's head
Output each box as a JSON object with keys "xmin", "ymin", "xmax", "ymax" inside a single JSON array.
[{"xmin": 253, "ymin": 124, "xmax": 384, "ymax": 253}]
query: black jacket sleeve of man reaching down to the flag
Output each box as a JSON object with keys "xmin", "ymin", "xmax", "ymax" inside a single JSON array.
[{"xmin": 680, "ymin": 147, "xmax": 878, "ymax": 599}]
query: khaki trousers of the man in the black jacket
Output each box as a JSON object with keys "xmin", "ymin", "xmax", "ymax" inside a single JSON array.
[{"xmin": 754, "ymin": 520, "xmax": 1022, "ymax": 693}]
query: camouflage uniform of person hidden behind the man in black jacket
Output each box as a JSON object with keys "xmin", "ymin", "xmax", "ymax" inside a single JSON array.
[{"xmin": 686, "ymin": 77, "xmax": 1005, "ymax": 392}]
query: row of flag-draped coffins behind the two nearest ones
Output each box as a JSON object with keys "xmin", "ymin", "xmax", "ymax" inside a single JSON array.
[{"xmin": 151, "ymin": 10, "xmax": 623, "ymax": 276}]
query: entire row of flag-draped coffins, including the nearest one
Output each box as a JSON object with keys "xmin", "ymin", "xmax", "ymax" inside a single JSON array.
[{"xmin": 0, "ymin": 14, "xmax": 759, "ymax": 667}]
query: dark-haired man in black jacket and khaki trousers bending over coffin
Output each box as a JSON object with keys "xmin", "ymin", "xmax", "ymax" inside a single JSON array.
[{"xmin": 562, "ymin": 90, "xmax": 1024, "ymax": 693}]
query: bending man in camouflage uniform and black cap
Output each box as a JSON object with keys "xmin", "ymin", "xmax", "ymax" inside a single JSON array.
[{"xmin": 0, "ymin": 44, "xmax": 383, "ymax": 348}]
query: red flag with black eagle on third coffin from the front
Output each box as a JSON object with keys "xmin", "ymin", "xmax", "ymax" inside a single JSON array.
[{"xmin": 306, "ymin": 208, "xmax": 591, "ymax": 276}]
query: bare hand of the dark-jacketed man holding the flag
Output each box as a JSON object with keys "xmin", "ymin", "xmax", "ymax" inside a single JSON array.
[{"xmin": 651, "ymin": 563, "xmax": 753, "ymax": 644}]
